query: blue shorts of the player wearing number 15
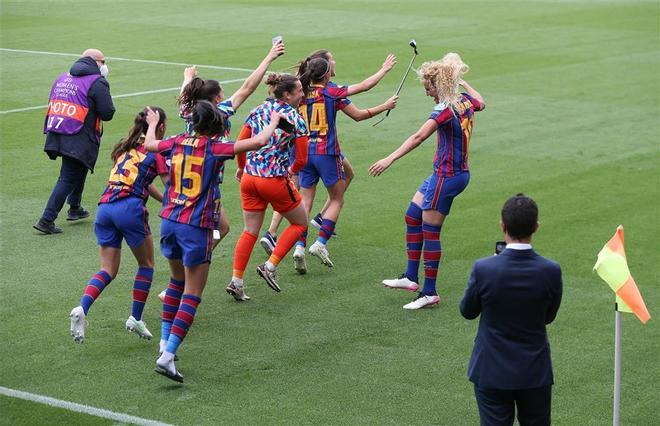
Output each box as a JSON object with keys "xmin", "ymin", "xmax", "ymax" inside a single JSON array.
[{"xmin": 160, "ymin": 219, "xmax": 213, "ymax": 267}]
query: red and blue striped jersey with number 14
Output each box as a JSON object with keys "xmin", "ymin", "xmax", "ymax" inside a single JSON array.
[{"xmin": 298, "ymin": 83, "xmax": 350, "ymax": 155}]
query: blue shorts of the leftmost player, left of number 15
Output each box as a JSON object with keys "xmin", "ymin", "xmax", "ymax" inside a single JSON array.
[{"xmin": 94, "ymin": 196, "xmax": 151, "ymax": 248}]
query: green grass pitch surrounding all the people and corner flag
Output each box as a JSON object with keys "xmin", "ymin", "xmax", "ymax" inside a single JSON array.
[{"xmin": 0, "ymin": 0, "xmax": 660, "ymax": 425}]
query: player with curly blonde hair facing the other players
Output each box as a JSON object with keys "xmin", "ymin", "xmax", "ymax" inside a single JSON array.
[{"xmin": 369, "ymin": 53, "xmax": 486, "ymax": 309}]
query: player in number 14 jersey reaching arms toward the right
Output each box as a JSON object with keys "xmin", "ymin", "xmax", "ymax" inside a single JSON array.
[{"xmin": 264, "ymin": 54, "xmax": 398, "ymax": 273}]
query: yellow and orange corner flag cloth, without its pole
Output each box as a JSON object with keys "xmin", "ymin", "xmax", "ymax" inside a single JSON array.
[{"xmin": 594, "ymin": 225, "xmax": 651, "ymax": 324}]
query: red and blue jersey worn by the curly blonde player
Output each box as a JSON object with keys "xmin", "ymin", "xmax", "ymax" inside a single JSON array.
[{"xmin": 429, "ymin": 93, "xmax": 483, "ymax": 177}]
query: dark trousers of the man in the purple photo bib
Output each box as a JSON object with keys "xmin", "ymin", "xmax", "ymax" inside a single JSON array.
[{"xmin": 42, "ymin": 157, "xmax": 87, "ymax": 221}]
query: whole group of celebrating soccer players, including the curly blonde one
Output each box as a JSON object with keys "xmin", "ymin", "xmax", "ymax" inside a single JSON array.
[{"xmin": 70, "ymin": 40, "xmax": 485, "ymax": 382}]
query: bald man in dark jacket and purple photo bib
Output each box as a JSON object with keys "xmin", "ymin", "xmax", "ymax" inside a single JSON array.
[{"xmin": 34, "ymin": 49, "xmax": 115, "ymax": 234}]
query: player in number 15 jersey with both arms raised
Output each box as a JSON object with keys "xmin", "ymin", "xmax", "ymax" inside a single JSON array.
[{"xmin": 144, "ymin": 101, "xmax": 279, "ymax": 382}]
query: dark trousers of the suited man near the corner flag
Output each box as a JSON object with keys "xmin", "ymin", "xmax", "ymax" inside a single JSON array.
[{"xmin": 474, "ymin": 385, "xmax": 552, "ymax": 426}]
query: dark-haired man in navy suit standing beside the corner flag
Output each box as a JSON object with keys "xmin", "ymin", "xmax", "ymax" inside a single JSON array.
[{"xmin": 460, "ymin": 194, "xmax": 562, "ymax": 425}]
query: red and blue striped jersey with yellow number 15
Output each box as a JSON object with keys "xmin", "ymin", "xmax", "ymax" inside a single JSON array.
[{"xmin": 158, "ymin": 133, "xmax": 234, "ymax": 229}]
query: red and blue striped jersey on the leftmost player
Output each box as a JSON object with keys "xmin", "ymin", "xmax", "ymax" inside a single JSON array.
[{"xmin": 99, "ymin": 145, "xmax": 168, "ymax": 204}]
